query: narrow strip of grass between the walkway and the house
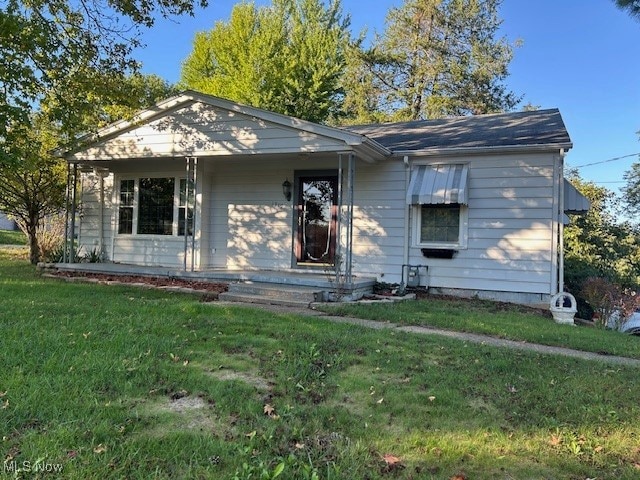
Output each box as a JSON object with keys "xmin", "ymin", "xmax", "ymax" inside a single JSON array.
[{"xmin": 322, "ymin": 296, "xmax": 640, "ymax": 358}]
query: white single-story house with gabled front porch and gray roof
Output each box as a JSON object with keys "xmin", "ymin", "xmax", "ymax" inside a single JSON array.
[{"xmin": 64, "ymin": 91, "xmax": 588, "ymax": 303}]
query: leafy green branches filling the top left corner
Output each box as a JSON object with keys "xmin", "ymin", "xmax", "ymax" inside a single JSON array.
[{"xmin": 0, "ymin": 0, "xmax": 207, "ymax": 163}]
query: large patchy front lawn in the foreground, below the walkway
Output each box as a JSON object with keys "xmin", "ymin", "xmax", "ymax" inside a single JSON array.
[{"xmin": 0, "ymin": 251, "xmax": 640, "ymax": 479}]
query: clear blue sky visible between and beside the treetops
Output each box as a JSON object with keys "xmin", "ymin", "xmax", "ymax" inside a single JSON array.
[{"xmin": 136, "ymin": 0, "xmax": 640, "ymax": 191}]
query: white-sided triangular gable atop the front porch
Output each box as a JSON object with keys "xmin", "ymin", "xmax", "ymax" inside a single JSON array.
[{"xmin": 65, "ymin": 92, "xmax": 389, "ymax": 161}]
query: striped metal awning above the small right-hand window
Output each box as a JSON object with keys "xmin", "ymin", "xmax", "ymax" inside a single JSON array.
[{"xmin": 407, "ymin": 164, "xmax": 469, "ymax": 205}]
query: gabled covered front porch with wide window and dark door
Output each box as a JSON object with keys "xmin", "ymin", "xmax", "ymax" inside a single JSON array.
[{"xmin": 60, "ymin": 92, "xmax": 389, "ymax": 293}]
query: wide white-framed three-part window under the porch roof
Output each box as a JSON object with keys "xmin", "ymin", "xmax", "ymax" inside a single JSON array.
[{"xmin": 118, "ymin": 177, "xmax": 194, "ymax": 236}]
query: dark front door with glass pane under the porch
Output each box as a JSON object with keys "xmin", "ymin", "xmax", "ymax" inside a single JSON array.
[{"xmin": 296, "ymin": 175, "xmax": 338, "ymax": 265}]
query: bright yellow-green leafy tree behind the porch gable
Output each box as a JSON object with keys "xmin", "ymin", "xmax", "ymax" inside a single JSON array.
[{"xmin": 180, "ymin": 0, "xmax": 350, "ymax": 122}]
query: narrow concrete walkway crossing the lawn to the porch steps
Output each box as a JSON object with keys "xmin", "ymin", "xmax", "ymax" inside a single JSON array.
[{"xmin": 213, "ymin": 302, "xmax": 640, "ymax": 367}]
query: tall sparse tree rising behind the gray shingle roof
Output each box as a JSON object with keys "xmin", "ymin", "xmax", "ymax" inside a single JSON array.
[{"xmin": 347, "ymin": 0, "xmax": 519, "ymax": 120}]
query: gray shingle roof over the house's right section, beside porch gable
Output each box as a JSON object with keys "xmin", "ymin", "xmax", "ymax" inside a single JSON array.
[{"xmin": 345, "ymin": 108, "xmax": 572, "ymax": 152}]
